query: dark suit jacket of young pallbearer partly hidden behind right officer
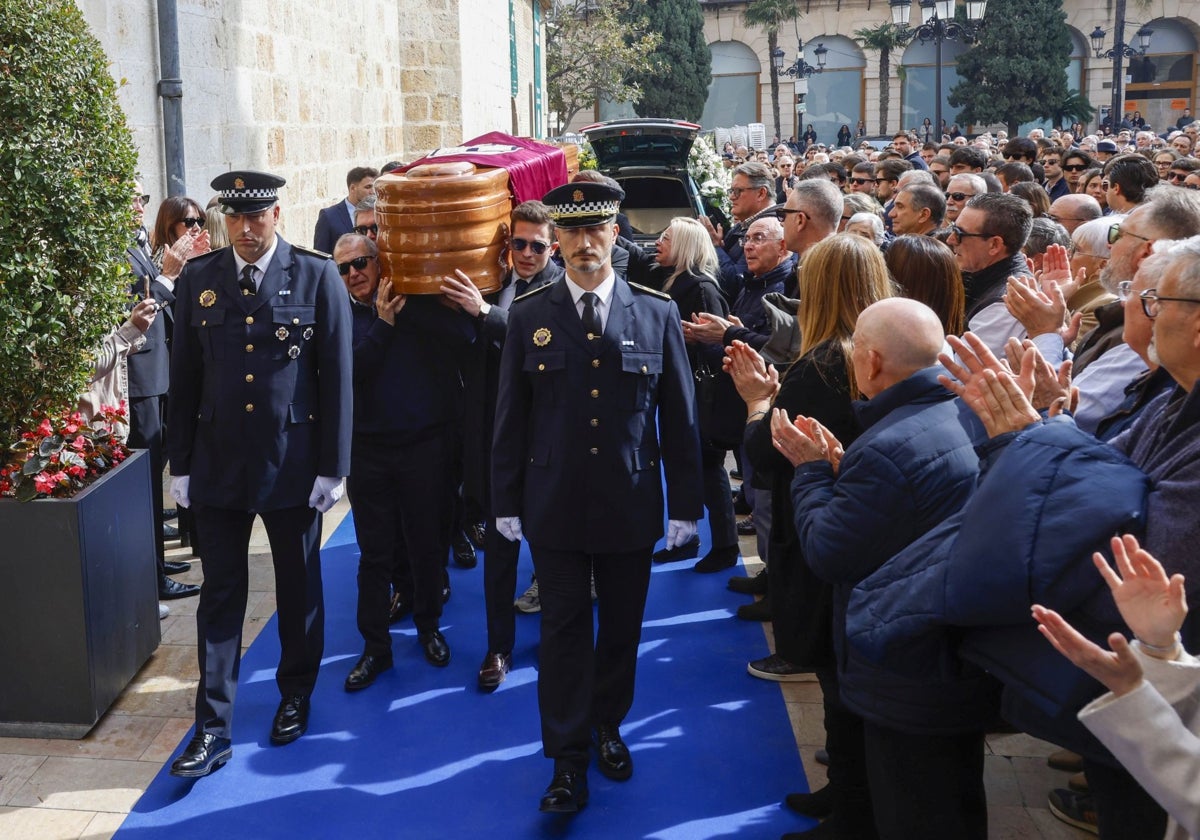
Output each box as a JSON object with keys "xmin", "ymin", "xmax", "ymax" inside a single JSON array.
[{"xmin": 462, "ymin": 260, "xmax": 564, "ymax": 510}]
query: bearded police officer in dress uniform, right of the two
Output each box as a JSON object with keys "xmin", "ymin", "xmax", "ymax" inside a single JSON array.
[{"xmin": 492, "ymin": 182, "xmax": 702, "ymax": 812}]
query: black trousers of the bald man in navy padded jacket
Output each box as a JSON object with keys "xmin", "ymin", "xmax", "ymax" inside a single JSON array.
[{"xmin": 868, "ymin": 721, "xmax": 988, "ymax": 840}]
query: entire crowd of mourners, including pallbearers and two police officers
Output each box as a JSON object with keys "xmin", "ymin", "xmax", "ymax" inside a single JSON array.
[{"xmin": 98, "ymin": 114, "xmax": 1200, "ymax": 839}]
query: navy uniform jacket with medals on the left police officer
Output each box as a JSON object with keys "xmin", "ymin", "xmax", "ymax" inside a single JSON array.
[{"xmin": 167, "ymin": 239, "xmax": 354, "ymax": 511}]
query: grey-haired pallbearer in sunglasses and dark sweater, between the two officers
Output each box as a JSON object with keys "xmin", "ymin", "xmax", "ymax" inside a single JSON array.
[{"xmin": 334, "ymin": 233, "xmax": 475, "ymax": 691}]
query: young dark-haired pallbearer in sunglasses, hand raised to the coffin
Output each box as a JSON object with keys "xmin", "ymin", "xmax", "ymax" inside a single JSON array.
[{"xmin": 442, "ymin": 202, "xmax": 563, "ymax": 692}]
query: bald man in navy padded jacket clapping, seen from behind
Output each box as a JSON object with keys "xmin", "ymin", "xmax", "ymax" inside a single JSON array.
[{"xmin": 772, "ymin": 298, "xmax": 995, "ymax": 840}]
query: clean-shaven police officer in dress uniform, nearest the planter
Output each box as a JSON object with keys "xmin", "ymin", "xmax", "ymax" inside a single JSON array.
[{"xmin": 168, "ymin": 172, "xmax": 353, "ymax": 776}]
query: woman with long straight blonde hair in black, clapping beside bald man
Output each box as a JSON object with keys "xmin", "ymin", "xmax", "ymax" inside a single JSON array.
[{"xmin": 726, "ymin": 234, "xmax": 893, "ymax": 836}]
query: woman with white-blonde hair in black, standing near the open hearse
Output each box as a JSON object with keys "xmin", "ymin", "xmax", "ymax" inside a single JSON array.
[{"xmin": 654, "ymin": 216, "xmax": 745, "ymax": 572}]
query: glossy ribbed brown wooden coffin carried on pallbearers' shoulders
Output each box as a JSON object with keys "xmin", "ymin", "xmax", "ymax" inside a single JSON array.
[{"xmin": 374, "ymin": 161, "xmax": 512, "ymax": 294}]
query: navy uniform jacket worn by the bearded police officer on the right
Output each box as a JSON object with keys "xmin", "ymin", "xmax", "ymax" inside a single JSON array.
[{"xmin": 492, "ymin": 273, "xmax": 702, "ymax": 553}]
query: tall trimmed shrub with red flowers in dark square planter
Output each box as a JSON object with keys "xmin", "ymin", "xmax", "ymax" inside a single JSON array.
[{"xmin": 0, "ymin": 0, "xmax": 160, "ymax": 737}]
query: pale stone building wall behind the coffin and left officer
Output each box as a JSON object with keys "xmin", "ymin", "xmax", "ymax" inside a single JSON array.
[{"xmin": 77, "ymin": 0, "xmax": 539, "ymax": 245}]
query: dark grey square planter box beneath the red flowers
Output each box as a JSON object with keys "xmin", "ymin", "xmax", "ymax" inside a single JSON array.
[{"xmin": 0, "ymin": 451, "xmax": 161, "ymax": 738}]
